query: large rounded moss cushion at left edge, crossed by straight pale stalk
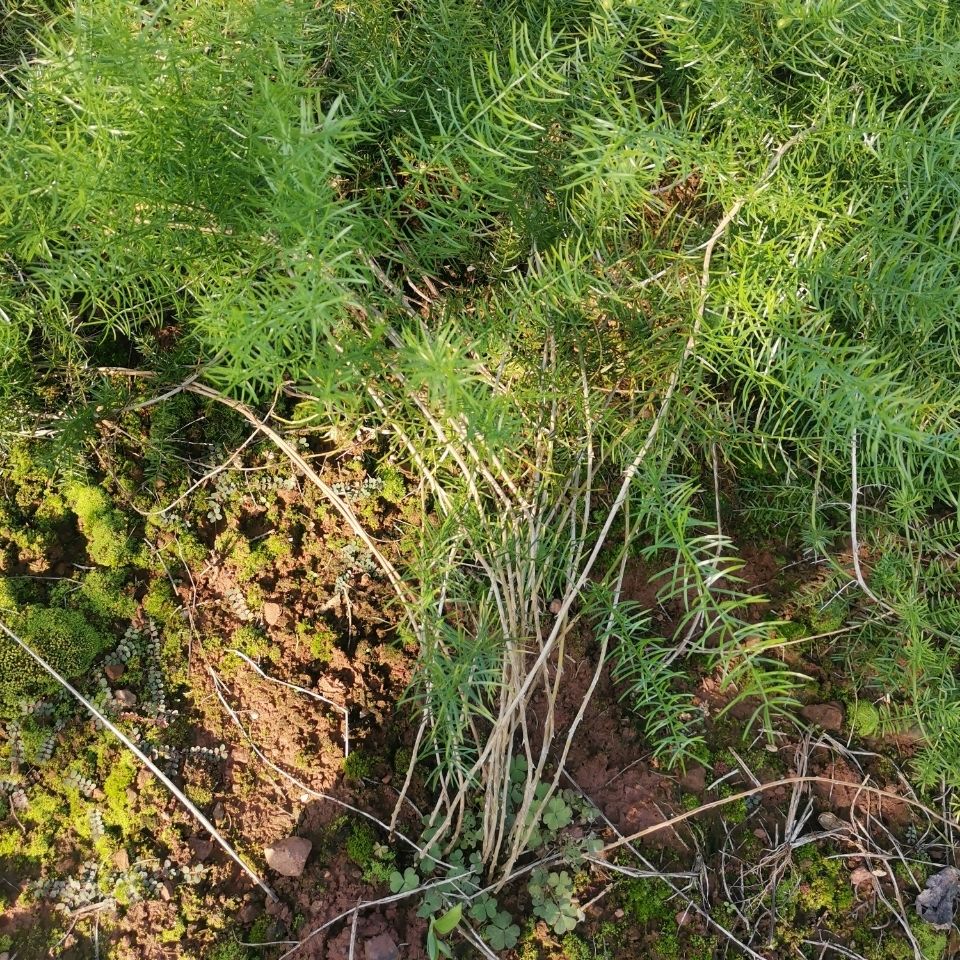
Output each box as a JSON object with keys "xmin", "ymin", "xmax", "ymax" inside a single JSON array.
[{"xmin": 0, "ymin": 606, "xmax": 111, "ymax": 712}]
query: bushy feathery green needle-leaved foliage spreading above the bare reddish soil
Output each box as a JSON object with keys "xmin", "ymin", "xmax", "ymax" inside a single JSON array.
[{"xmin": 0, "ymin": 0, "xmax": 960, "ymax": 824}]
